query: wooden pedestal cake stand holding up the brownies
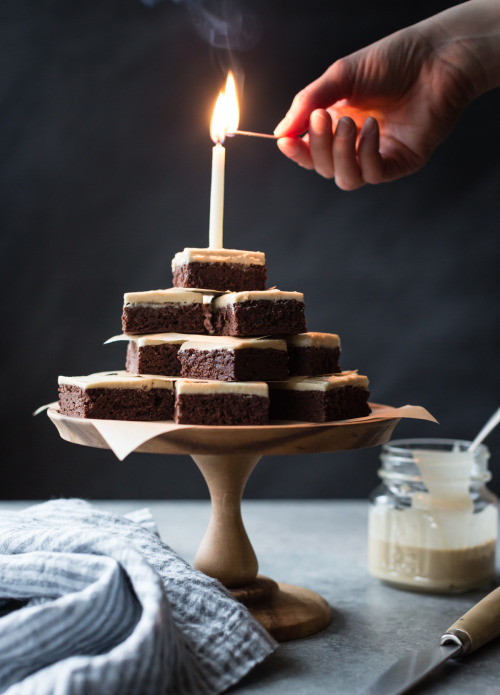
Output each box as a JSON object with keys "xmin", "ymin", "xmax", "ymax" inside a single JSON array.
[{"xmin": 47, "ymin": 403, "xmax": 400, "ymax": 642}]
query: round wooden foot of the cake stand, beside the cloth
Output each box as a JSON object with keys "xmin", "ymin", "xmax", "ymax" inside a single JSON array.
[{"xmin": 231, "ymin": 575, "xmax": 332, "ymax": 642}]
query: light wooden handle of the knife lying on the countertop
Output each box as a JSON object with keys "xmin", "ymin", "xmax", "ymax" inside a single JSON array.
[{"xmin": 441, "ymin": 587, "xmax": 500, "ymax": 656}]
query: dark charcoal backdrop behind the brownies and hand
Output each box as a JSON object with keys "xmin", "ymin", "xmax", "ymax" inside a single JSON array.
[{"xmin": 0, "ymin": 0, "xmax": 500, "ymax": 499}]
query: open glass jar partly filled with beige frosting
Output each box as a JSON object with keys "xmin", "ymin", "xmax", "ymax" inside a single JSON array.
[{"xmin": 368, "ymin": 439, "xmax": 498, "ymax": 593}]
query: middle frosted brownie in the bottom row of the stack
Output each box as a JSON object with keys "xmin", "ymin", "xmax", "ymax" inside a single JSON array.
[{"xmin": 174, "ymin": 379, "xmax": 269, "ymax": 425}]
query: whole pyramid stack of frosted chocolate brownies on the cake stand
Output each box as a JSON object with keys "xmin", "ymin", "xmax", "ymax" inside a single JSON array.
[{"xmin": 59, "ymin": 248, "xmax": 370, "ymax": 426}]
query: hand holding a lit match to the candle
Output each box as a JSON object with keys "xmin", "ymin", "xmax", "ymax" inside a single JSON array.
[{"xmin": 275, "ymin": 22, "xmax": 474, "ymax": 190}]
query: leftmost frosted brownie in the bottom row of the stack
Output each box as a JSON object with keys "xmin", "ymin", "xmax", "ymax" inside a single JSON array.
[{"xmin": 59, "ymin": 371, "xmax": 174, "ymax": 420}]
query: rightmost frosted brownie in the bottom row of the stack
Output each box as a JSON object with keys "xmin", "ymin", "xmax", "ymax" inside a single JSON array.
[{"xmin": 269, "ymin": 372, "xmax": 371, "ymax": 422}]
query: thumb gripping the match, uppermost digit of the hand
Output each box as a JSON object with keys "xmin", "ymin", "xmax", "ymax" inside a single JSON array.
[{"xmin": 274, "ymin": 60, "xmax": 352, "ymax": 137}]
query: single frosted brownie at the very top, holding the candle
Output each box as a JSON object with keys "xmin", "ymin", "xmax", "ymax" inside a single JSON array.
[{"xmin": 172, "ymin": 248, "xmax": 267, "ymax": 292}]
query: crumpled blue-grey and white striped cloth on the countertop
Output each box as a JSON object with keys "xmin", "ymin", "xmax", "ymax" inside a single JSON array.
[{"xmin": 0, "ymin": 500, "xmax": 276, "ymax": 695}]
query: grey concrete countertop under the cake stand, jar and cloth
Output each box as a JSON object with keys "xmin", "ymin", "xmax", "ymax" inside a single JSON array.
[{"xmin": 0, "ymin": 500, "xmax": 500, "ymax": 695}]
